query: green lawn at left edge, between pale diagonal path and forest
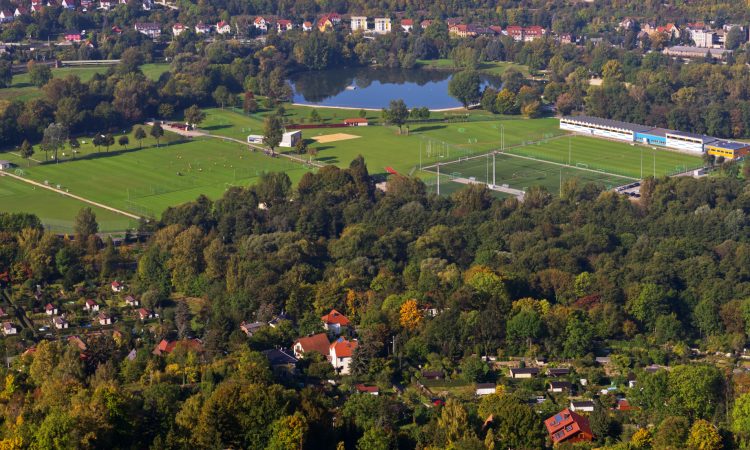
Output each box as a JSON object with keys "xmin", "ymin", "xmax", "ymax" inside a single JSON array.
[{"xmin": 0, "ymin": 177, "xmax": 137, "ymax": 233}]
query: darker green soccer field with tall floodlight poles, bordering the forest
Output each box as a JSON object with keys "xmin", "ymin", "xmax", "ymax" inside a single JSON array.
[{"xmin": 428, "ymin": 153, "xmax": 635, "ymax": 194}]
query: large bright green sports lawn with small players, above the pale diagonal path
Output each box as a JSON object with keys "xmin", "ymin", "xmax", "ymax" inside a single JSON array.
[{"xmin": 2, "ymin": 133, "xmax": 307, "ymax": 221}]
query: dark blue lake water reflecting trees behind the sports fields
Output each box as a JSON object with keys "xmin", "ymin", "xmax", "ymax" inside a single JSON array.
[{"xmin": 290, "ymin": 67, "xmax": 499, "ymax": 109}]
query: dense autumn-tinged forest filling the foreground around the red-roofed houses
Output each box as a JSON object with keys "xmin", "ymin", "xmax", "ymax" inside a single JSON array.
[{"xmin": 0, "ymin": 158, "xmax": 750, "ymax": 449}]
